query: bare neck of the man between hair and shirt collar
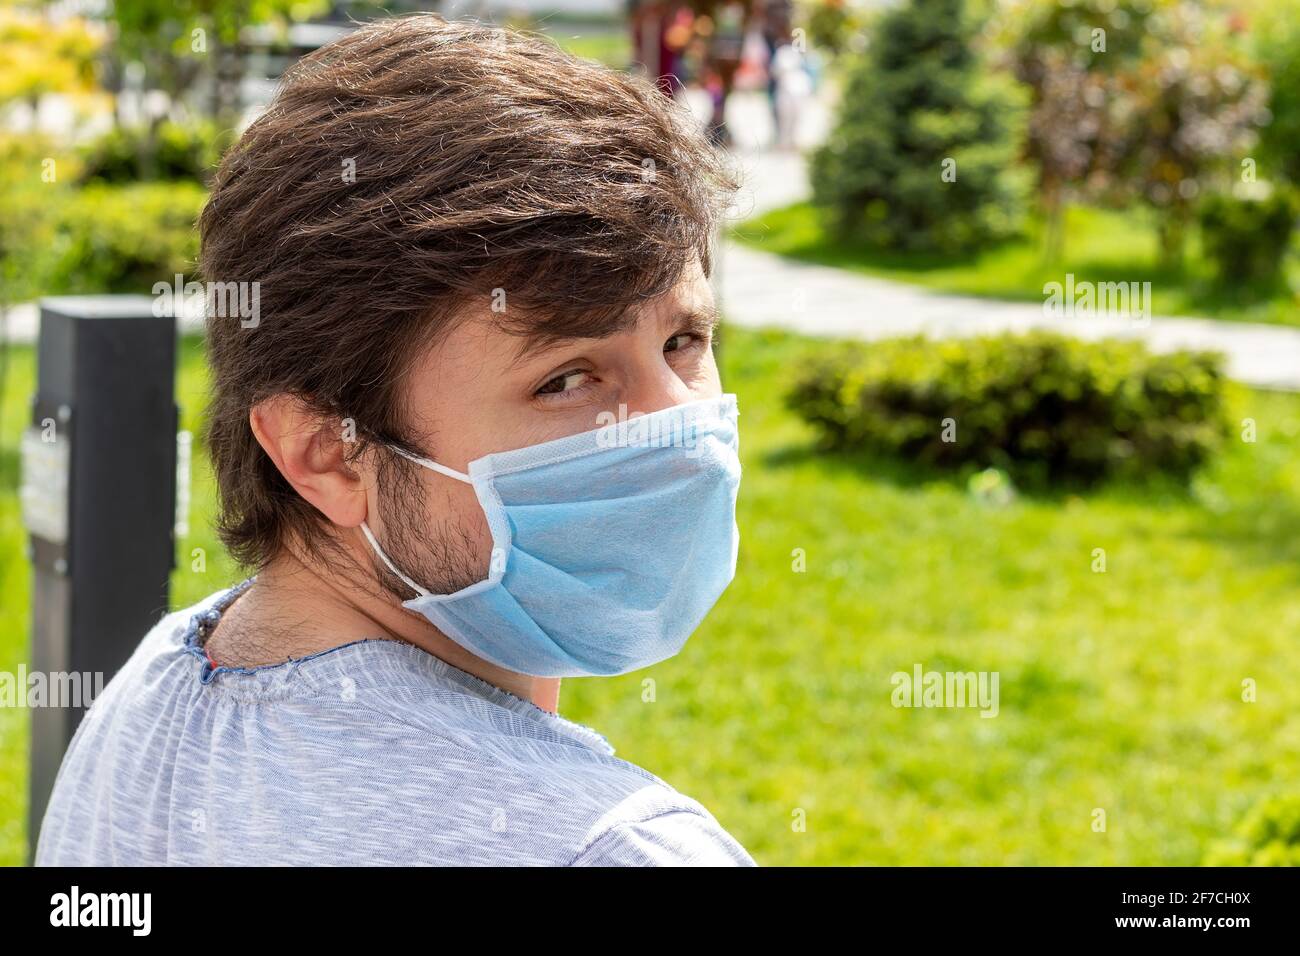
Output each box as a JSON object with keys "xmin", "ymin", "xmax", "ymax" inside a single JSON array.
[{"xmin": 207, "ymin": 553, "xmax": 560, "ymax": 713}]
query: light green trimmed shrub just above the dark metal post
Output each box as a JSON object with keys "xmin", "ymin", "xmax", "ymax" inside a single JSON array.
[{"xmin": 44, "ymin": 182, "xmax": 207, "ymax": 293}]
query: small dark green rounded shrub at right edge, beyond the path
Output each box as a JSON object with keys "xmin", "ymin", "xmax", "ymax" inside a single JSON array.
[{"xmin": 1200, "ymin": 189, "xmax": 1296, "ymax": 289}]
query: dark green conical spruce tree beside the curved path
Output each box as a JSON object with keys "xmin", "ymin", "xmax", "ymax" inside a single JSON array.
[{"xmin": 811, "ymin": 0, "xmax": 1026, "ymax": 252}]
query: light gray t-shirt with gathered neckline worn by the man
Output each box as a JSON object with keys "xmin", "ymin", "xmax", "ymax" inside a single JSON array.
[{"xmin": 36, "ymin": 581, "xmax": 755, "ymax": 866}]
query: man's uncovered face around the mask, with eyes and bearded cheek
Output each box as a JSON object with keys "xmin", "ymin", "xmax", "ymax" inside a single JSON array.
[{"xmin": 369, "ymin": 263, "xmax": 722, "ymax": 597}]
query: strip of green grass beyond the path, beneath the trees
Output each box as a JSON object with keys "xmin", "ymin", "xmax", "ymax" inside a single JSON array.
[{"xmin": 732, "ymin": 203, "xmax": 1300, "ymax": 325}]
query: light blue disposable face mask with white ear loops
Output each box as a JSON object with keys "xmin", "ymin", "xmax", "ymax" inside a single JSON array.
[{"xmin": 361, "ymin": 394, "xmax": 741, "ymax": 678}]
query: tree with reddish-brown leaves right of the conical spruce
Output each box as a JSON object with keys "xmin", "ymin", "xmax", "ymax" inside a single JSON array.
[{"xmin": 1001, "ymin": 0, "xmax": 1266, "ymax": 268}]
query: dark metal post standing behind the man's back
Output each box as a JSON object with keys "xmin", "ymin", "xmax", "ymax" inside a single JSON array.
[{"xmin": 22, "ymin": 295, "xmax": 177, "ymax": 857}]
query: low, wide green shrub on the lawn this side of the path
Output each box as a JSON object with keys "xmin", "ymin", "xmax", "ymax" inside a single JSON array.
[{"xmin": 787, "ymin": 333, "xmax": 1227, "ymax": 485}]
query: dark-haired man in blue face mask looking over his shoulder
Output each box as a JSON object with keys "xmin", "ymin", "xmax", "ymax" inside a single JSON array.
[{"xmin": 36, "ymin": 16, "xmax": 754, "ymax": 865}]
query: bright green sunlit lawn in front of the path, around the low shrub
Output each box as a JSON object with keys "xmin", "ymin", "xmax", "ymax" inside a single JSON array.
[{"xmin": 0, "ymin": 329, "xmax": 1300, "ymax": 865}]
